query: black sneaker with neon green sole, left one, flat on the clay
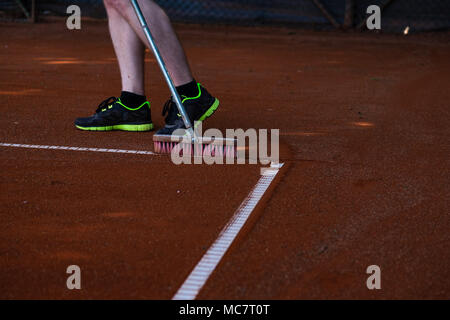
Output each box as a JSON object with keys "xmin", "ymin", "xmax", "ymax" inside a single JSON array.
[{"xmin": 75, "ymin": 97, "xmax": 153, "ymax": 131}]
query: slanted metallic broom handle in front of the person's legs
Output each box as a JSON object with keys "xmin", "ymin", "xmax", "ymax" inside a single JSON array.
[{"xmin": 131, "ymin": 0, "xmax": 194, "ymax": 132}]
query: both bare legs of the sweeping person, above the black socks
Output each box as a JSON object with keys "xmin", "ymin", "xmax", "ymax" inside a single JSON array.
[{"xmin": 104, "ymin": 0, "xmax": 193, "ymax": 90}]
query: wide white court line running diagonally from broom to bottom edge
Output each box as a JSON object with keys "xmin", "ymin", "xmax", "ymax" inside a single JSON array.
[{"xmin": 172, "ymin": 163, "xmax": 283, "ymax": 300}]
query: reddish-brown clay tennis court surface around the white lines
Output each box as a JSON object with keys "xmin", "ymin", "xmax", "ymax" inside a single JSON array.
[{"xmin": 0, "ymin": 20, "xmax": 450, "ymax": 299}]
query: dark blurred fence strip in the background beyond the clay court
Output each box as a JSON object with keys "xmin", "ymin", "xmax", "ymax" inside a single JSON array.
[{"xmin": 0, "ymin": 0, "xmax": 450, "ymax": 32}]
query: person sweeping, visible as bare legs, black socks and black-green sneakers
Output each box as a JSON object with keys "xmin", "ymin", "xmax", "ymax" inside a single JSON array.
[{"xmin": 75, "ymin": 0, "xmax": 219, "ymax": 134}]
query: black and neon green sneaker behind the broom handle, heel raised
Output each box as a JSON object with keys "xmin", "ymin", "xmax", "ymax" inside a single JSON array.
[{"xmin": 156, "ymin": 83, "xmax": 219, "ymax": 135}]
